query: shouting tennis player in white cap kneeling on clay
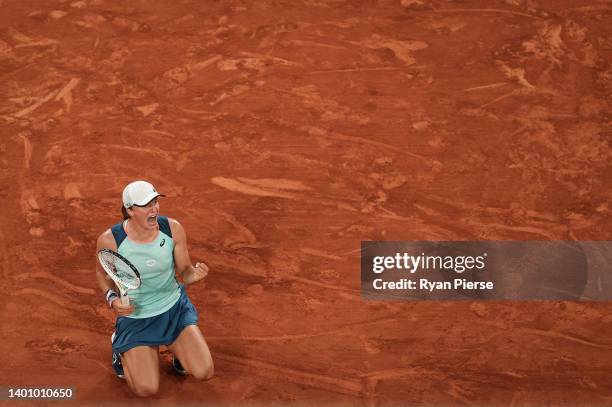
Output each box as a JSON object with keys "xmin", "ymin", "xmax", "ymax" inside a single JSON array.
[{"xmin": 96, "ymin": 181, "xmax": 213, "ymax": 397}]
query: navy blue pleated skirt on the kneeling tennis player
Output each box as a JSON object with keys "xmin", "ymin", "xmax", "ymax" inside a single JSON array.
[{"xmin": 113, "ymin": 284, "xmax": 198, "ymax": 353}]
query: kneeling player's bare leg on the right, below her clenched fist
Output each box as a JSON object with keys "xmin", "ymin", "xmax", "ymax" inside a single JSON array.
[{"xmin": 168, "ymin": 325, "xmax": 214, "ymax": 380}]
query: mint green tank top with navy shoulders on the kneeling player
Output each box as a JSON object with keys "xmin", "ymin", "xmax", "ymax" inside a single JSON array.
[{"xmin": 113, "ymin": 217, "xmax": 181, "ymax": 318}]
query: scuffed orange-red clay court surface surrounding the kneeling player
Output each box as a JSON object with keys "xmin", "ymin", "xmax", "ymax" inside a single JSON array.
[{"xmin": 0, "ymin": 0, "xmax": 612, "ymax": 406}]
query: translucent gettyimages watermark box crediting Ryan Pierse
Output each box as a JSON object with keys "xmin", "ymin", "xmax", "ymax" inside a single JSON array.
[{"xmin": 361, "ymin": 241, "xmax": 612, "ymax": 301}]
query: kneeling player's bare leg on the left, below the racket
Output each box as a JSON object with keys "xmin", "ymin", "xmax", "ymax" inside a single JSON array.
[{"xmin": 121, "ymin": 346, "xmax": 159, "ymax": 397}]
